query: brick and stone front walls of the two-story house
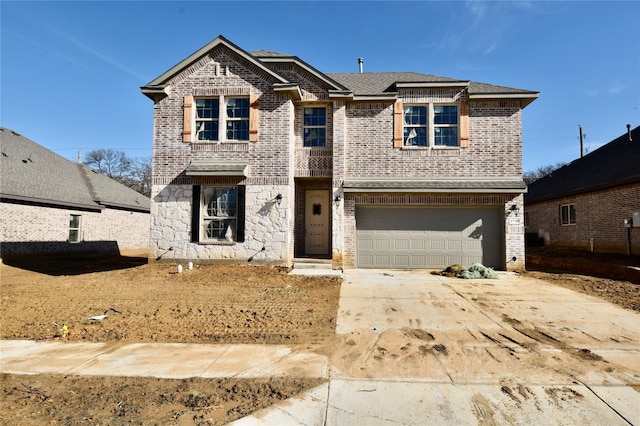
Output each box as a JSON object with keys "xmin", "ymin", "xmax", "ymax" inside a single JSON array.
[{"xmin": 149, "ymin": 36, "xmax": 536, "ymax": 269}]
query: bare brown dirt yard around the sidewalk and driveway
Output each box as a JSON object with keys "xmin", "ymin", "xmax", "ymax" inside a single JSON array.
[{"xmin": 0, "ymin": 251, "xmax": 640, "ymax": 425}]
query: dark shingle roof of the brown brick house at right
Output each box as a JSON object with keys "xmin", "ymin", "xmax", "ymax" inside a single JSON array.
[{"xmin": 525, "ymin": 127, "xmax": 640, "ymax": 203}]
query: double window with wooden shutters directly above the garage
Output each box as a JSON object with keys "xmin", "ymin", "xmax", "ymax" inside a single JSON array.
[{"xmin": 402, "ymin": 104, "xmax": 460, "ymax": 147}]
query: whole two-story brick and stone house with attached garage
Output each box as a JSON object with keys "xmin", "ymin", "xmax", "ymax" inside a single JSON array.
[{"xmin": 141, "ymin": 36, "xmax": 538, "ymax": 269}]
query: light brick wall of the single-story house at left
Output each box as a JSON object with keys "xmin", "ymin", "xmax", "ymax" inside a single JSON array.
[{"xmin": 0, "ymin": 202, "xmax": 150, "ymax": 255}]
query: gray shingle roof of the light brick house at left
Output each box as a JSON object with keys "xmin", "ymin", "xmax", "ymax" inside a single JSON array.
[{"xmin": 0, "ymin": 127, "xmax": 150, "ymax": 211}]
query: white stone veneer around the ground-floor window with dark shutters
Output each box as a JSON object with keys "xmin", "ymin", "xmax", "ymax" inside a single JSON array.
[{"xmin": 150, "ymin": 185, "xmax": 292, "ymax": 265}]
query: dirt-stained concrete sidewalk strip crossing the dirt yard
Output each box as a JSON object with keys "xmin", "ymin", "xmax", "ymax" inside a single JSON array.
[{"xmin": 0, "ymin": 340, "xmax": 328, "ymax": 379}]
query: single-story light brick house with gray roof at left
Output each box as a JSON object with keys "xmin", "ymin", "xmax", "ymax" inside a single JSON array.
[{"xmin": 0, "ymin": 128, "xmax": 150, "ymax": 258}]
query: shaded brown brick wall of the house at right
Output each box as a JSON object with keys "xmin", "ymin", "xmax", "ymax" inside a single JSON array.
[{"xmin": 526, "ymin": 184, "xmax": 640, "ymax": 254}]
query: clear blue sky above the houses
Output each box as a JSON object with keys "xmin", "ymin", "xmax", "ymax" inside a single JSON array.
[{"xmin": 0, "ymin": 0, "xmax": 640, "ymax": 171}]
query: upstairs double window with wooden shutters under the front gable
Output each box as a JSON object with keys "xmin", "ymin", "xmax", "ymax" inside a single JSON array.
[{"xmin": 194, "ymin": 96, "xmax": 249, "ymax": 141}]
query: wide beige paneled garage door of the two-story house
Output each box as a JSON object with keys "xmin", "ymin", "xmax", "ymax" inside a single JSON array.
[{"xmin": 356, "ymin": 207, "xmax": 503, "ymax": 269}]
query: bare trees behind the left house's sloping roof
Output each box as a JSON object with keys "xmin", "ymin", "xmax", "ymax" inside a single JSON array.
[{"xmin": 84, "ymin": 149, "xmax": 151, "ymax": 197}]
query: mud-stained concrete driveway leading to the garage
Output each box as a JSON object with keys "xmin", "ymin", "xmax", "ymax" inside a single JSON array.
[{"xmin": 235, "ymin": 270, "xmax": 640, "ymax": 425}]
